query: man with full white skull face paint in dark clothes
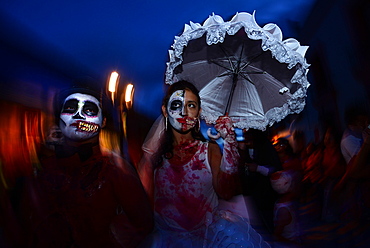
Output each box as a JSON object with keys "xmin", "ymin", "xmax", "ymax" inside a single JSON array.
[{"xmin": 28, "ymin": 87, "xmax": 153, "ymax": 248}]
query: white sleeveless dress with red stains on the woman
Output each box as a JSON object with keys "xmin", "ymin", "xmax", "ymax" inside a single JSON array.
[{"xmin": 145, "ymin": 141, "xmax": 269, "ymax": 248}]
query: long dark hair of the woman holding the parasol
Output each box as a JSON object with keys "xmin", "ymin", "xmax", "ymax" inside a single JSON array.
[{"xmin": 153, "ymin": 80, "xmax": 204, "ymax": 167}]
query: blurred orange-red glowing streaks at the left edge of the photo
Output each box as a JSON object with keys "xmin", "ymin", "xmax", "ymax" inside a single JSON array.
[{"xmin": 0, "ymin": 102, "xmax": 43, "ymax": 188}]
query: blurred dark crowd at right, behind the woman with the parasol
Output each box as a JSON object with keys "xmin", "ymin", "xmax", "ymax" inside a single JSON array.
[{"xmin": 234, "ymin": 105, "xmax": 370, "ymax": 247}]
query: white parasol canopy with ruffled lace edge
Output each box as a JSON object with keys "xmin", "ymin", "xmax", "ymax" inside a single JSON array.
[{"xmin": 166, "ymin": 12, "xmax": 309, "ymax": 130}]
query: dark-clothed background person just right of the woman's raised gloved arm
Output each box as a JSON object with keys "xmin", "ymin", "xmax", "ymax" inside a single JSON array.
[{"xmin": 239, "ymin": 129, "xmax": 282, "ymax": 235}]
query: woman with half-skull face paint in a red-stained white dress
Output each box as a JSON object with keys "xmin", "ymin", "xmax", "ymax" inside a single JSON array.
[{"xmin": 139, "ymin": 81, "xmax": 268, "ymax": 248}]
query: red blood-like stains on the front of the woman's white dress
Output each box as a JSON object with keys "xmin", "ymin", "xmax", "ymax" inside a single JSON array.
[{"xmin": 155, "ymin": 141, "xmax": 217, "ymax": 230}]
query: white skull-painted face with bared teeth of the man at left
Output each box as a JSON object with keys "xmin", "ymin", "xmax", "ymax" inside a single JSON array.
[{"xmin": 59, "ymin": 93, "xmax": 103, "ymax": 141}]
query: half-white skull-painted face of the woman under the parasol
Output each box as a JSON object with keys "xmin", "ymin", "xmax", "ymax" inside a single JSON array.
[{"xmin": 167, "ymin": 90, "xmax": 199, "ymax": 132}]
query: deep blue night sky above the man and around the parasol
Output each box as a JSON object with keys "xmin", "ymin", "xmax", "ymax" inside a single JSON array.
[{"xmin": 0, "ymin": 0, "xmax": 314, "ymax": 117}]
